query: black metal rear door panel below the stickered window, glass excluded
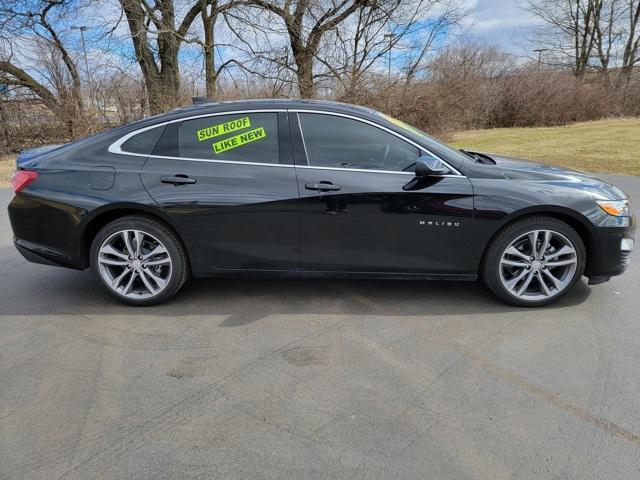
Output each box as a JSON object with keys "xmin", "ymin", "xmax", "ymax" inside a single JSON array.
[{"xmin": 142, "ymin": 158, "xmax": 300, "ymax": 275}]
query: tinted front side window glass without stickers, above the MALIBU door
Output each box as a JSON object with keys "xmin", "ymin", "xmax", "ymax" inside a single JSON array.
[{"xmin": 299, "ymin": 113, "xmax": 421, "ymax": 172}]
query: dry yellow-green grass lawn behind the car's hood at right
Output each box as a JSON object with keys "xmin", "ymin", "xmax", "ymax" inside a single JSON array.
[{"xmin": 448, "ymin": 118, "xmax": 640, "ymax": 175}]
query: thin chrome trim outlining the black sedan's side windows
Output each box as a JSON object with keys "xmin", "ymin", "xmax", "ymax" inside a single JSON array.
[{"xmin": 107, "ymin": 108, "xmax": 467, "ymax": 178}]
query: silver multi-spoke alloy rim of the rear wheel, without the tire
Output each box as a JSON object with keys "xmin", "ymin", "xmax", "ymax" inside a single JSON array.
[{"xmin": 97, "ymin": 230, "xmax": 172, "ymax": 299}]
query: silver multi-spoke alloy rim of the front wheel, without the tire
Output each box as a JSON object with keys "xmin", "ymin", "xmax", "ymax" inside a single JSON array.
[{"xmin": 499, "ymin": 230, "xmax": 578, "ymax": 301}]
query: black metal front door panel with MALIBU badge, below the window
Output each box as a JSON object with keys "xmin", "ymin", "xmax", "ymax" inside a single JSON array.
[{"xmin": 298, "ymin": 168, "xmax": 477, "ymax": 274}]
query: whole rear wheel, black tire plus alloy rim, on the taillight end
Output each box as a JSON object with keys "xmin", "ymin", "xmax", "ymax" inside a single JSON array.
[{"xmin": 89, "ymin": 215, "xmax": 189, "ymax": 306}]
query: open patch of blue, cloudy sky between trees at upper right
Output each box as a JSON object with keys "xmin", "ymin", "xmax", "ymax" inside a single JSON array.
[{"xmin": 465, "ymin": 0, "xmax": 535, "ymax": 55}]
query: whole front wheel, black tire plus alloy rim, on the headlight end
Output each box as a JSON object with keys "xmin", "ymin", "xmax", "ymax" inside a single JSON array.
[{"xmin": 481, "ymin": 215, "xmax": 587, "ymax": 307}]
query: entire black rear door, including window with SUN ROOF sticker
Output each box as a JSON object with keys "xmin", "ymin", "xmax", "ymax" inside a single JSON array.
[{"xmin": 142, "ymin": 111, "xmax": 300, "ymax": 274}]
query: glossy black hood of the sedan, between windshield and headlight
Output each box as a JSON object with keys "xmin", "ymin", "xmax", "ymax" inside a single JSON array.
[{"xmin": 478, "ymin": 154, "xmax": 628, "ymax": 200}]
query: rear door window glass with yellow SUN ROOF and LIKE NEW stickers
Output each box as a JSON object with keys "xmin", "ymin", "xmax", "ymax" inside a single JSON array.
[{"xmin": 178, "ymin": 113, "xmax": 280, "ymax": 163}]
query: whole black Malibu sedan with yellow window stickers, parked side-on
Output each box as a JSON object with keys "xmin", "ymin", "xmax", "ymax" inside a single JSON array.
[{"xmin": 9, "ymin": 100, "xmax": 636, "ymax": 306}]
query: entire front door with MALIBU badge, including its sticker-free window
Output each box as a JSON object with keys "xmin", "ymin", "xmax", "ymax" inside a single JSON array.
[{"xmin": 290, "ymin": 111, "xmax": 477, "ymax": 274}]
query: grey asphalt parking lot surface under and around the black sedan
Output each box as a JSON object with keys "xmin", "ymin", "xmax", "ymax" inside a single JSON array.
[{"xmin": 0, "ymin": 175, "xmax": 640, "ymax": 480}]
